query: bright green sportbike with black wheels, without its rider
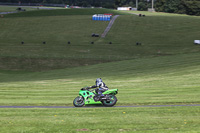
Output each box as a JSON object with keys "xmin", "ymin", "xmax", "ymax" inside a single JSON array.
[{"xmin": 73, "ymin": 88, "xmax": 118, "ymax": 107}]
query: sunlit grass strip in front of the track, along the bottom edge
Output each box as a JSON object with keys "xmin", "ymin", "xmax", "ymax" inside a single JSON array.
[{"xmin": 0, "ymin": 107, "xmax": 200, "ymax": 133}]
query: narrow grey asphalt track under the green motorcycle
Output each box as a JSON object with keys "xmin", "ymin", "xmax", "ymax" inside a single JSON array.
[{"xmin": 0, "ymin": 104, "xmax": 200, "ymax": 109}]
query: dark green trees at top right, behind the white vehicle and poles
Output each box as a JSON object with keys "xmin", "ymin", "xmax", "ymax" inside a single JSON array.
[{"xmin": 115, "ymin": 0, "xmax": 200, "ymax": 16}]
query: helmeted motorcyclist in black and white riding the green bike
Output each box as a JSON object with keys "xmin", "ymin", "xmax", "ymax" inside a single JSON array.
[{"xmin": 87, "ymin": 78, "xmax": 108, "ymax": 97}]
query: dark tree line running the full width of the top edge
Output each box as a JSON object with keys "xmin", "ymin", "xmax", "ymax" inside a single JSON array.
[{"xmin": 0, "ymin": 0, "xmax": 200, "ymax": 16}]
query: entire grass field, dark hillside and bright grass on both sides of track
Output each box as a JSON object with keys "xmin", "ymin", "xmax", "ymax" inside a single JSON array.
[{"xmin": 0, "ymin": 9, "xmax": 200, "ymax": 133}]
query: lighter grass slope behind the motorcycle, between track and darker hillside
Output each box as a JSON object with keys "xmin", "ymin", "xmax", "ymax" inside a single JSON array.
[{"xmin": 0, "ymin": 54, "xmax": 200, "ymax": 106}]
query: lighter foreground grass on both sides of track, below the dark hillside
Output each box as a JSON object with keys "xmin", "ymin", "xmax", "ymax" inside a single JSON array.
[{"xmin": 0, "ymin": 53, "xmax": 200, "ymax": 133}]
